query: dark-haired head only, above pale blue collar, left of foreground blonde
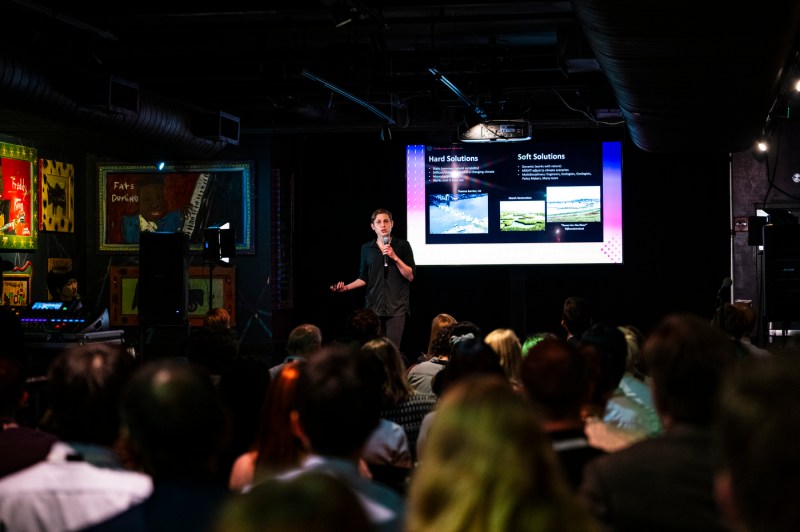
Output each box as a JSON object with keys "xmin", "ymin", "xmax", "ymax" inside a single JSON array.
[{"xmin": 292, "ymin": 343, "xmax": 385, "ymax": 460}]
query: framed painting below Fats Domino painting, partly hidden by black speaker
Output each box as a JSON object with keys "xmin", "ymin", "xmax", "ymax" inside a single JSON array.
[{"xmin": 108, "ymin": 266, "xmax": 236, "ymax": 327}]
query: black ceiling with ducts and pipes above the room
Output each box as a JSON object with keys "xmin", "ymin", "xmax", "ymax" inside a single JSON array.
[{"xmin": 0, "ymin": 0, "xmax": 800, "ymax": 157}]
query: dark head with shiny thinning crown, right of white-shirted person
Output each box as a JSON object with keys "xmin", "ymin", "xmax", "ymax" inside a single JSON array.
[{"xmin": 122, "ymin": 359, "xmax": 228, "ymax": 483}]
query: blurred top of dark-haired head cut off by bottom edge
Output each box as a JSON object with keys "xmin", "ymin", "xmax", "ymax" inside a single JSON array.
[{"xmin": 214, "ymin": 472, "xmax": 375, "ymax": 532}]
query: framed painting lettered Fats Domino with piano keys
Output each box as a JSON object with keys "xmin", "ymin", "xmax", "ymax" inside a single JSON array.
[{"xmin": 97, "ymin": 162, "xmax": 255, "ymax": 254}]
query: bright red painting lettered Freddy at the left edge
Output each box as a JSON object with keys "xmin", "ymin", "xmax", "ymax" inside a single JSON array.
[{"xmin": 0, "ymin": 142, "xmax": 39, "ymax": 250}]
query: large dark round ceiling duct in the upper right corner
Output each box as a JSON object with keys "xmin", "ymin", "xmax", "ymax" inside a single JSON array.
[{"xmin": 572, "ymin": 0, "xmax": 800, "ymax": 153}]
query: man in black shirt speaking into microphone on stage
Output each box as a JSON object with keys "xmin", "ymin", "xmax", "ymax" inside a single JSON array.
[{"xmin": 330, "ymin": 209, "xmax": 416, "ymax": 349}]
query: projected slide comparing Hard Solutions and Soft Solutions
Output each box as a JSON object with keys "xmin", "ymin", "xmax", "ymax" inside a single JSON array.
[{"xmin": 406, "ymin": 141, "xmax": 622, "ymax": 265}]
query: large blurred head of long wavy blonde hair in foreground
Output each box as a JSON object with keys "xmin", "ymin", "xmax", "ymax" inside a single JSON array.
[{"xmin": 406, "ymin": 372, "xmax": 597, "ymax": 532}]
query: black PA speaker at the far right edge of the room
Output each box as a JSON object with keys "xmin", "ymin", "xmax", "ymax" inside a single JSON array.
[{"xmin": 764, "ymin": 224, "xmax": 800, "ymax": 323}]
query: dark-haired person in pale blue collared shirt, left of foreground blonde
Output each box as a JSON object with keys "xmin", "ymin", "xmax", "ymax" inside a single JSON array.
[{"xmin": 280, "ymin": 344, "xmax": 405, "ymax": 531}]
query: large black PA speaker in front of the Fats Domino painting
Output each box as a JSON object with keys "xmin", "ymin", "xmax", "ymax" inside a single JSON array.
[{"xmin": 137, "ymin": 232, "xmax": 189, "ymax": 326}]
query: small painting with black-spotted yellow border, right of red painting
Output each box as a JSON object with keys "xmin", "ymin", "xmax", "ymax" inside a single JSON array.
[{"xmin": 39, "ymin": 159, "xmax": 75, "ymax": 233}]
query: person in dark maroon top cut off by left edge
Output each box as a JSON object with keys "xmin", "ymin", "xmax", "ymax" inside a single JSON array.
[{"xmin": 0, "ymin": 312, "xmax": 58, "ymax": 478}]
